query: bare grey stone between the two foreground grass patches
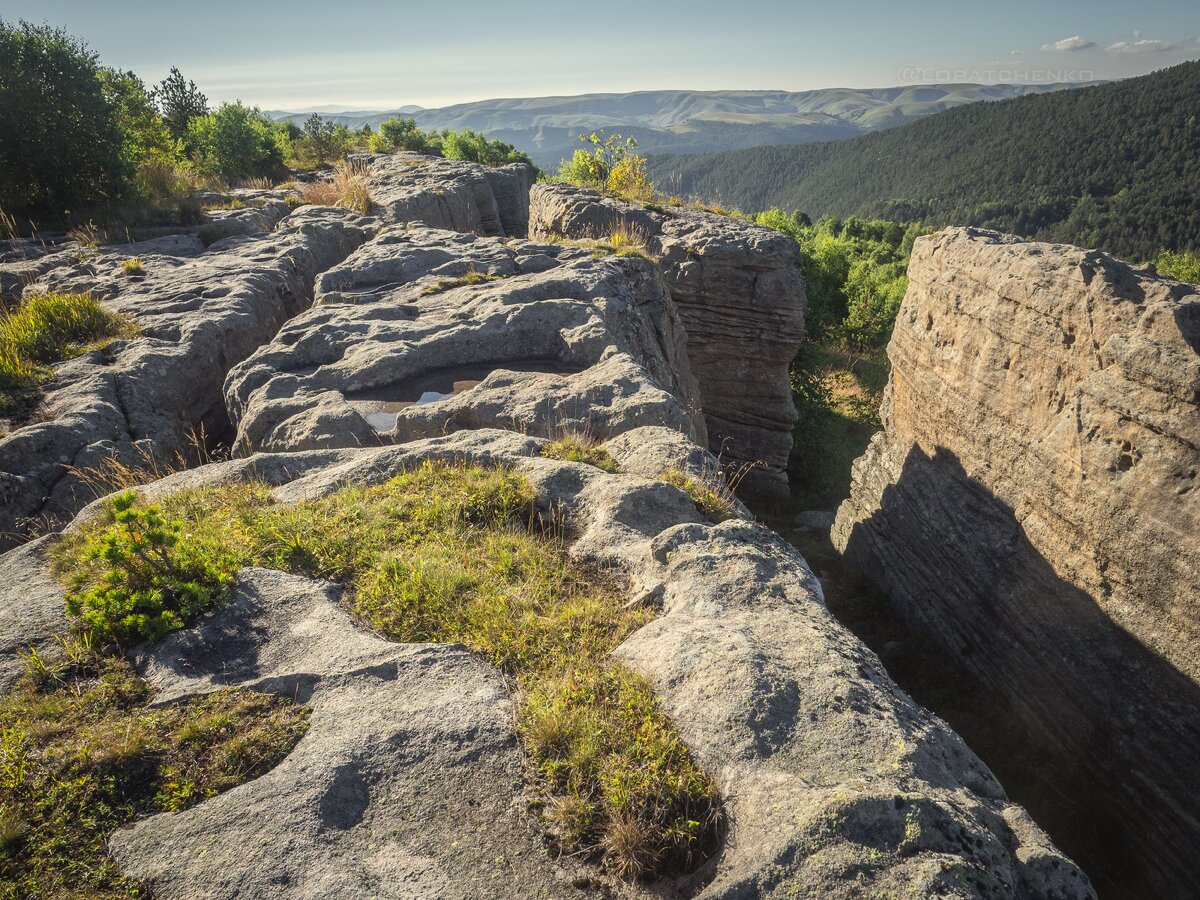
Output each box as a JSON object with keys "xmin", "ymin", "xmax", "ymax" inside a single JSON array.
[{"xmin": 110, "ymin": 569, "xmax": 600, "ymax": 900}]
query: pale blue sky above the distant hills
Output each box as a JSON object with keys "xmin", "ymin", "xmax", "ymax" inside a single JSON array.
[{"xmin": 0, "ymin": 0, "xmax": 1200, "ymax": 110}]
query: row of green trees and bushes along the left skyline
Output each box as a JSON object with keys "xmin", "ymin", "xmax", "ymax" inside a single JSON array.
[{"xmin": 0, "ymin": 19, "xmax": 529, "ymax": 230}]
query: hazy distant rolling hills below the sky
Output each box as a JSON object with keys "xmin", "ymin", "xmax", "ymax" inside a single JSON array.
[{"xmin": 268, "ymin": 83, "xmax": 1081, "ymax": 169}]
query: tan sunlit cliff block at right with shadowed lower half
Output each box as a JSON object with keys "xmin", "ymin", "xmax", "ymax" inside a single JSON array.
[{"xmin": 834, "ymin": 229, "xmax": 1200, "ymax": 898}]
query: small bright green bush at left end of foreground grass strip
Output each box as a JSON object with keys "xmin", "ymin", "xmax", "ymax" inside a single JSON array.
[{"xmin": 66, "ymin": 491, "xmax": 236, "ymax": 648}]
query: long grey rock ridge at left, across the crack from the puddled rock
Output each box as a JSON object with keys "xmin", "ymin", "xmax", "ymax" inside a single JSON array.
[{"xmin": 0, "ymin": 208, "xmax": 377, "ymax": 546}]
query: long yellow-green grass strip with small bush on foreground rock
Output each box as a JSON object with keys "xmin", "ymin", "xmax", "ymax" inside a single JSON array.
[{"xmin": 56, "ymin": 463, "xmax": 721, "ymax": 878}]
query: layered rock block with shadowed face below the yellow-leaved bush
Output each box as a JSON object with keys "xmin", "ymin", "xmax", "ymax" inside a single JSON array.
[{"xmin": 529, "ymin": 184, "xmax": 805, "ymax": 503}]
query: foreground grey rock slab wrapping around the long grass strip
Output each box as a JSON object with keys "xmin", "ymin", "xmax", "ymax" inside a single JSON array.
[{"xmin": 6, "ymin": 430, "xmax": 1093, "ymax": 900}]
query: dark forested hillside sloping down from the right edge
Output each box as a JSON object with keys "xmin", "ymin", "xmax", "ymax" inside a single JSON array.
[{"xmin": 649, "ymin": 61, "xmax": 1200, "ymax": 260}]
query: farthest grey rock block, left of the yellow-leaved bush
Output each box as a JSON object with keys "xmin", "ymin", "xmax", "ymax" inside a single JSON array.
[{"xmin": 362, "ymin": 152, "xmax": 536, "ymax": 238}]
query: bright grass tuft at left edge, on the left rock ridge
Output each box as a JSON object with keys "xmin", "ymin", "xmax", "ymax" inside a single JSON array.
[{"xmin": 0, "ymin": 294, "xmax": 136, "ymax": 415}]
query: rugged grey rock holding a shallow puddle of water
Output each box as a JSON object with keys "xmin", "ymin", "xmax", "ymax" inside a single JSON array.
[{"xmin": 226, "ymin": 227, "xmax": 704, "ymax": 452}]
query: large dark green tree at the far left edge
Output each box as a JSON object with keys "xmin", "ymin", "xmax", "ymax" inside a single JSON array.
[{"xmin": 0, "ymin": 19, "xmax": 133, "ymax": 220}]
